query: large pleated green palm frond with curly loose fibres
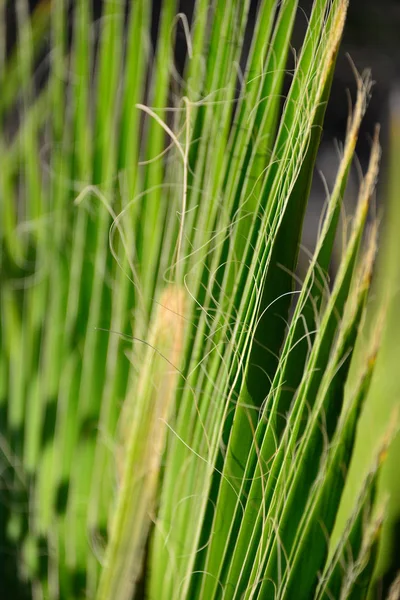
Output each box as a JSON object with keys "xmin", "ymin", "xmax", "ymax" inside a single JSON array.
[{"xmin": 0, "ymin": 0, "xmax": 395, "ymax": 600}]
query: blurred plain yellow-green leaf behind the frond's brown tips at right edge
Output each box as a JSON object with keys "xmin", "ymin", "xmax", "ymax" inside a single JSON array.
[{"xmin": 333, "ymin": 86, "xmax": 400, "ymax": 598}]
